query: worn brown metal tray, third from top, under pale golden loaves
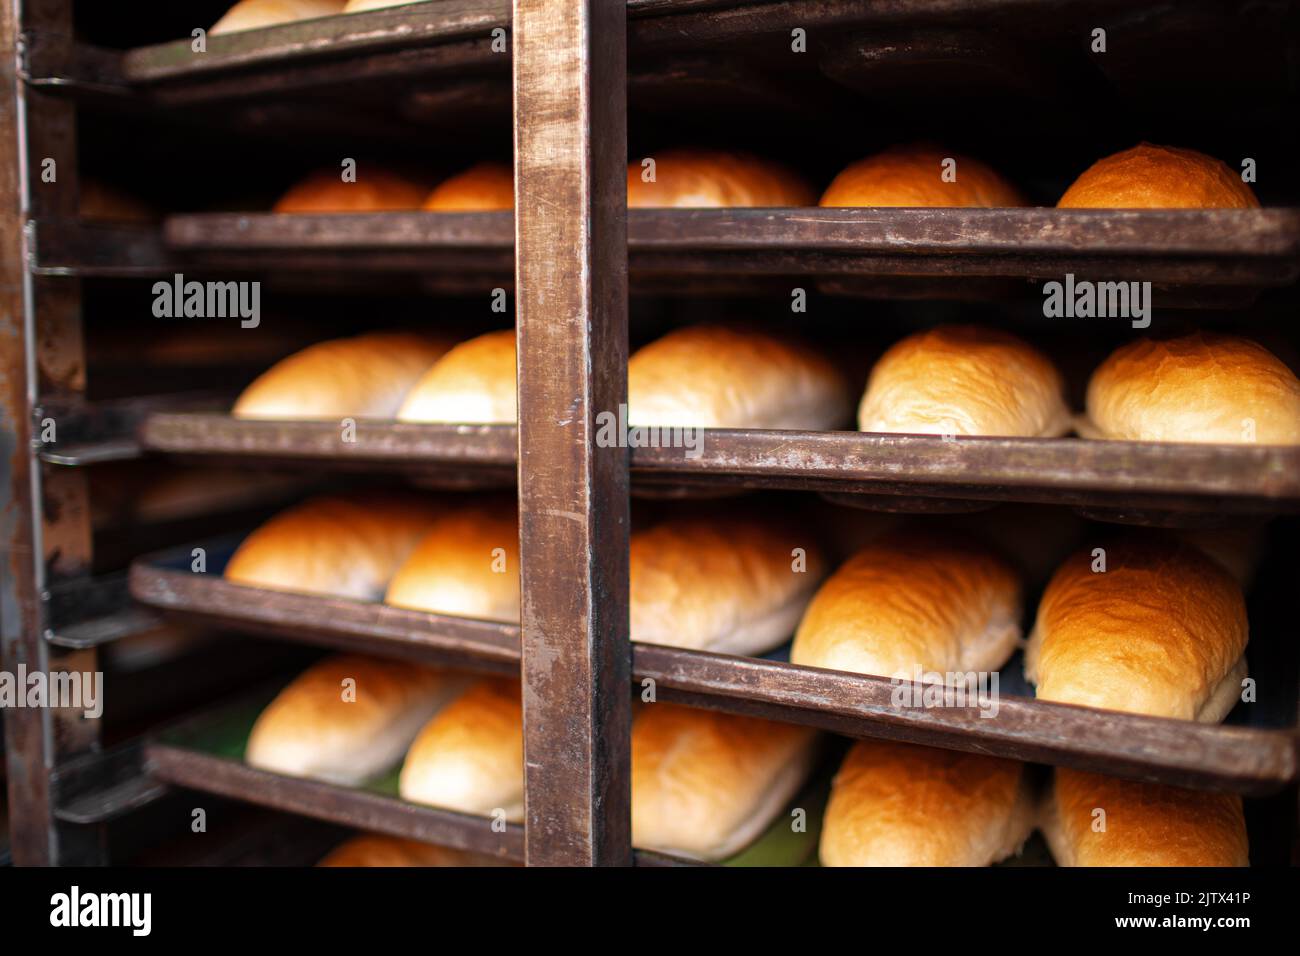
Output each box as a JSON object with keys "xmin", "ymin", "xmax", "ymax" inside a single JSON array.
[{"xmin": 138, "ymin": 412, "xmax": 1300, "ymax": 525}]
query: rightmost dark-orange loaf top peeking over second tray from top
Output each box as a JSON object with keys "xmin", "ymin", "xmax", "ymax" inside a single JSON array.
[{"xmin": 1057, "ymin": 143, "xmax": 1260, "ymax": 209}]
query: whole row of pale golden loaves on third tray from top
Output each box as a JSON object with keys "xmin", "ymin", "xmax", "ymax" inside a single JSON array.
[{"xmin": 233, "ymin": 325, "xmax": 1300, "ymax": 445}]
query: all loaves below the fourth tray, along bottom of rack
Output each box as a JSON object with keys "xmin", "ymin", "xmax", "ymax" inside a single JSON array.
[{"xmin": 244, "ymin": 656, "xmax": 1249, "ymax": 866}]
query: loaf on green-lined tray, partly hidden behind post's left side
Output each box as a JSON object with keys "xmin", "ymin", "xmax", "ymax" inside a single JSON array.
[{"xmin": 400, "ymin": 679, "xmax": 524, "ymax": 822}]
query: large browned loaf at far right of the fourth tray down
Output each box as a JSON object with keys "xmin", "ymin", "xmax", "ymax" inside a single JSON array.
[{"xmin": 1024, "ymin": 536, "xmax": 1248, "ymax": 723}]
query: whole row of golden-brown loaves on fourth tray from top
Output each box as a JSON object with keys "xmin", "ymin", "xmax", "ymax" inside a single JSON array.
[{"xmin": 225, "ymin": 494, "xmax": 1249, "ymax": 723}]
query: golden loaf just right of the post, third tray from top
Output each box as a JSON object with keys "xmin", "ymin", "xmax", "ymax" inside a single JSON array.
[{"xmin": 628, "ymin": 325, "xmax": 849, "ymax": 429}]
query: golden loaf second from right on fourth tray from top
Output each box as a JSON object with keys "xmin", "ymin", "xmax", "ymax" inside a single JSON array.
[{"xmin": 790, "ymin": 529, "xmax": 1021, "ymax": 680}]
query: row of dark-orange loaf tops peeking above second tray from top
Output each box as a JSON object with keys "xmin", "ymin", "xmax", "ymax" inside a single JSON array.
[{"xmin": 258, "ymin": 143, "xmax": 1260, "ymax": 213}]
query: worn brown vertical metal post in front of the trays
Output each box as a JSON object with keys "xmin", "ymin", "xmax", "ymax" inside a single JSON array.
[{"xmin": 512, "ymin": 0, "xmax": 631, "ymax": 866}]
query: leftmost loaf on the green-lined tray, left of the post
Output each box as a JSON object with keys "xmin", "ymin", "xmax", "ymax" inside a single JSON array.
[{"xmin": 244, "ymin": 654, "xmax": 464, "ymax": 786}]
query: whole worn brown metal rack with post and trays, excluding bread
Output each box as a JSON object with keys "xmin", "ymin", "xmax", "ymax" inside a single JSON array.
[{"xmin": 0, "ymin": 0, "xmax": 1300, "ymax": 865}]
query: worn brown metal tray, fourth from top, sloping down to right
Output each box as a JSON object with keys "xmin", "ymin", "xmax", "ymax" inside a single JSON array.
[{"xmin": 130, "ymin": 542, "xmax": 1300, "ymax": 795}]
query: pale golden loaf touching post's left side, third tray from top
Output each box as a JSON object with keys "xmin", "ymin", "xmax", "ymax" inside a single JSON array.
[{"xmin": 398, "ymin": 329, "xmax": 517, "ymax": 424}]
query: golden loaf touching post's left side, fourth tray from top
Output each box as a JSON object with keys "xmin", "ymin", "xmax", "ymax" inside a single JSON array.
[{"xmin": 384, "ymin": 502, "xmax": 519, "ymax": 623}]
